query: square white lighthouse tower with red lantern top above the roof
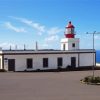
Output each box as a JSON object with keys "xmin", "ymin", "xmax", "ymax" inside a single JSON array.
[{"xmin": 61, "ymin": 21, "xmax": 79, "ymax": 50}]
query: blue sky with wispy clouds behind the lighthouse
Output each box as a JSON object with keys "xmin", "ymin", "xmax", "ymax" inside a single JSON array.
[{"xmin": 0, "ymin": 0, "xmax": 100, "ymax": 49}]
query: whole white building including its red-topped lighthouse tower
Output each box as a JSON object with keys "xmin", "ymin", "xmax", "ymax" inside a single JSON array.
[{"xmin": 0, "ymin": 22, "xmax": 96, "ymax": 71}]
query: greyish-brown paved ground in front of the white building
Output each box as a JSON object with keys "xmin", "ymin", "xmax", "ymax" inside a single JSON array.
[{"xmin": 0, "ymin": 71, "xmax": 100, "ymax": 100}]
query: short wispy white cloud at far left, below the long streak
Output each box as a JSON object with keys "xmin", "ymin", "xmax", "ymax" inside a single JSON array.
[{"xmin": 4, "ymin": 22, "xmax": 26, "ymax": 33}]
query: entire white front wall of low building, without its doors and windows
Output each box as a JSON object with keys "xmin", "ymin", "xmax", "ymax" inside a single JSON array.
[{"xmin": 4, "ymin": 53, "xmax": 95, "ymax": 71}]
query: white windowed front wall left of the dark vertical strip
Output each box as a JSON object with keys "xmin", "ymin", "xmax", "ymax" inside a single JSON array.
[{"xmin": 4, "ymin": 54, "xmax": 78, "ymax": 71}]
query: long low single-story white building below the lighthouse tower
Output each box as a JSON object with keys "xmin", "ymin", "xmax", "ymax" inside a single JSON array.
[{"xmin": 0, "ymin": 49, "xmax": 95, "ymax": 71}]
